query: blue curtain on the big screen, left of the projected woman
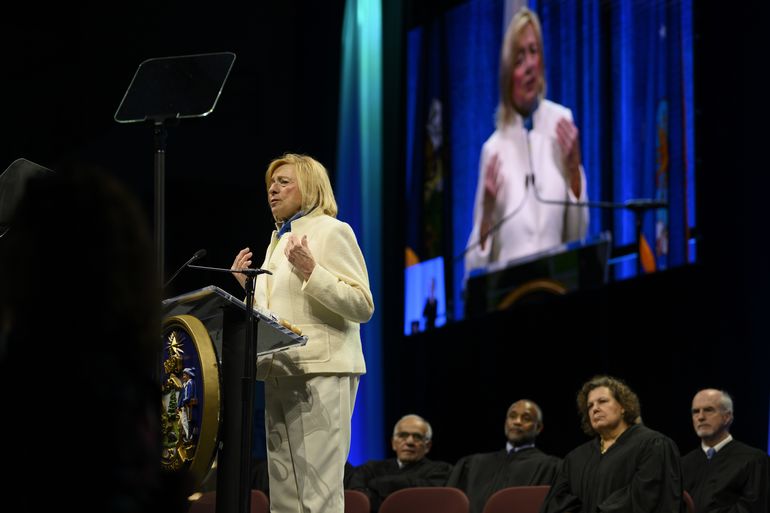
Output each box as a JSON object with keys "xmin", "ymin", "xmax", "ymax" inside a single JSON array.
[{"xmin": 405, "ymin": 0, "xmax": 503, "ymax": 320}]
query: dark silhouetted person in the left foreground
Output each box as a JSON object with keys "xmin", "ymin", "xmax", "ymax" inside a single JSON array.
[{"xmin": 0, "ymin": 166, "xmax": 188, "ymax": 513}]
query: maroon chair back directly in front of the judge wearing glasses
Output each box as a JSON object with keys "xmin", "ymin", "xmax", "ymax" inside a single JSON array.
[{"xmin": 380, "ymin": 486, "xmax": 469, "ymax": 513}]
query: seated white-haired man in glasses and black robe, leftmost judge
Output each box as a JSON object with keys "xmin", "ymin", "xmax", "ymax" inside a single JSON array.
[{"xmin": 347, "ymin": 415, "xmax": 452, "ymax": 512}]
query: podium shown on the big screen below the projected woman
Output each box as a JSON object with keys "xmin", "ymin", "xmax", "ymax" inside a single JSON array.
[{"xmin": 465, "ymin": 232, "xmax": 612, "ymax": 318}]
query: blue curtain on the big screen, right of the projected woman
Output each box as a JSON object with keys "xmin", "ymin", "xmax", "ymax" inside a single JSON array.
[{"xmin": 530, "ymin": 0, "xmax": 695, "ymax": 278}]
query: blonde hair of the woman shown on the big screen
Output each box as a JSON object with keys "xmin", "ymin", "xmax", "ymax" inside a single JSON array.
[{"xmin": 496, "ymin": 7, "xmax": 545, "ymax": 128}]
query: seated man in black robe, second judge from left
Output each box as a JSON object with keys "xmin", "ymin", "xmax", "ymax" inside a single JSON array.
[{"xmin": 447, "ymin": 399, "xmax": 561, "ymax": 513}]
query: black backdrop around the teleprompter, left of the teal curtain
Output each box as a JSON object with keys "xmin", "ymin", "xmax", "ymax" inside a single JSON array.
[{"xmin": 0, "ymin": 0, "xmax": 344, "ymax": 295}]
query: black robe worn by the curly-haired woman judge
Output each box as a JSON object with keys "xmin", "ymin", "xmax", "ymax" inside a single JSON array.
[{"xmin": 540, "ymin": 424, "xmax": 685, "ymax": 513}]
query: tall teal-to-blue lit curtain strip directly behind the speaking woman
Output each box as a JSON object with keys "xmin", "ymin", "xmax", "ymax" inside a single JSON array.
[{"xmin": 334, "ymin": 0, "xmax": 387, "ymax": 465}]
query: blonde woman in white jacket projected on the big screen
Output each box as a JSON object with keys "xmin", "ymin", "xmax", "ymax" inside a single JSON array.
[{"xmin": 465, "ymin": 7, "xmax": 588, "ymax": 272}]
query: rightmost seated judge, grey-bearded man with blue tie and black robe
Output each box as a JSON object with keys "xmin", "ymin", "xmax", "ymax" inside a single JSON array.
[{"xmin": 682, "ymin": 389, "xmax": 769, "ymax": 513}]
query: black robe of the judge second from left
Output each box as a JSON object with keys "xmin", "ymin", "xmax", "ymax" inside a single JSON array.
[{"xmin": 447, "ymin": 447, "xmax": 561, "ymax": 513}]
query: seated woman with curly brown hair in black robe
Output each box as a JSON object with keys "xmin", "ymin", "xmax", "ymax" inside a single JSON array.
[{"xmin": 541, "ymin": 376, "xmax": 684, "ymax": 513}]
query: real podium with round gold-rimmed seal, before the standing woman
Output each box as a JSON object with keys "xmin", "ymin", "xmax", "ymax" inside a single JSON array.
[{"xmin": 161, "ymin": 286, "xmax": 307, "ymax": 513}]
